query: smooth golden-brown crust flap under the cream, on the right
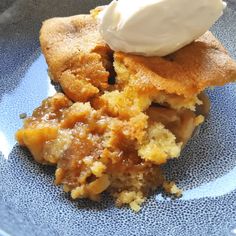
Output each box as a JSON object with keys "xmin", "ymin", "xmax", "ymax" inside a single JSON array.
[{"xmin": 114, "ymin": 31, "xmax": 236, "ymax": 97}]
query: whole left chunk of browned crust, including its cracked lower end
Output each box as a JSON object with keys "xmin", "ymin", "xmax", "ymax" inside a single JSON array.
[{"xmin": 40, "ymin": 15, "xmax": 112, "ymax": 102}]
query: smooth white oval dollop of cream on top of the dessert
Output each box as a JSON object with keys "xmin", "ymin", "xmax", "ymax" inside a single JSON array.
[{"xmin": 98, "ymin": 0, "xmax": 226, "ymax": 56}]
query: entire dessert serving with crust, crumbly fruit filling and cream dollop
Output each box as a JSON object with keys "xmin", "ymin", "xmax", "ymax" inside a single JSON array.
[{"xmin": 16, "ymin": 0, "xmax": 236, "ymax": 211}]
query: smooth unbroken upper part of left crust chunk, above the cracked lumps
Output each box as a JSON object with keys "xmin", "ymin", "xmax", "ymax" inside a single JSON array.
[{"xmin": 40, "ymin": 15, "xmax": 107, "ymax": 80}]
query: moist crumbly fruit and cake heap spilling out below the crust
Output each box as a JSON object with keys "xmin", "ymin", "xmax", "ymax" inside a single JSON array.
[{"xmin": 16, "ymin": 93, "xmax": 198, "ymax": 210}]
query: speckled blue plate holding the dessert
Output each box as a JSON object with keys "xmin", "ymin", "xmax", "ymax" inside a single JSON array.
[{"xmin": 0, "ymin": 0, "xmax": 236, "ymax": 236}]
